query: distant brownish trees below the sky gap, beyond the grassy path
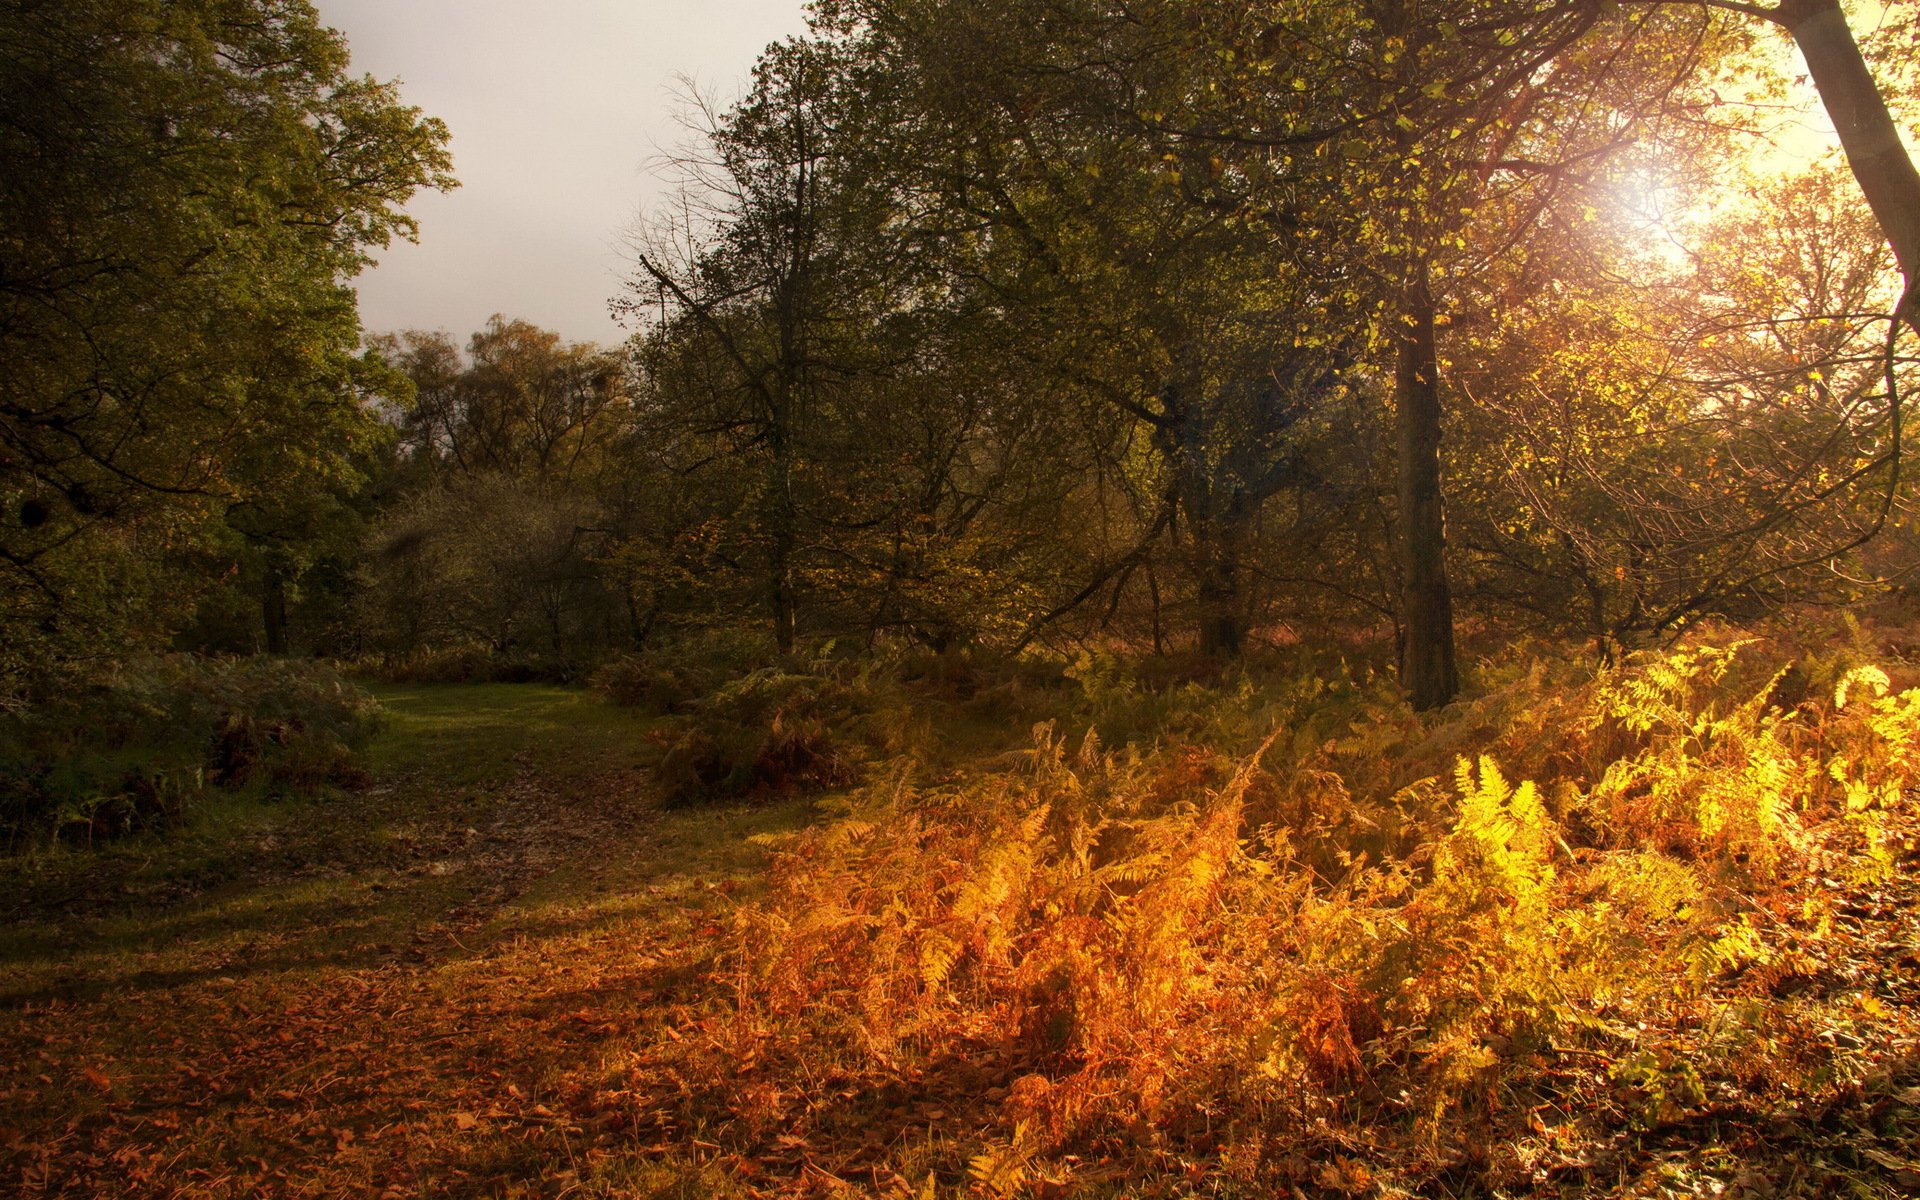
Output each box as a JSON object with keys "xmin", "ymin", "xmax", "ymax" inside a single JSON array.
[{"xmin": 359, "ymin": 315, "xmax": 645, "ymax": 664}]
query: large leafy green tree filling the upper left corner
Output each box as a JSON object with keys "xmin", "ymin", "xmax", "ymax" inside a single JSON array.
[{"xmin": 0, "ymin": 0, "xmax": 453, "ymax": 675}]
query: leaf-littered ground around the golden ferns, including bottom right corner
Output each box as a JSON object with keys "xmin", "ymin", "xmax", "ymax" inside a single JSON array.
[{"xmin": 0, "ymin": 685, "xmax": 1920, "ymax": 1200}]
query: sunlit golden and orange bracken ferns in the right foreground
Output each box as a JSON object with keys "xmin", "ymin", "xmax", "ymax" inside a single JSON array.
[{"xmin": 636, "ymin": 622, "xmax": 1920, "ymax": 1196}]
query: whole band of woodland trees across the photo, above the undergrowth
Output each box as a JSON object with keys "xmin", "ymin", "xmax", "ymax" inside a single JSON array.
[{"xmin": 15, "ymin": 0, "xmax": 1912, "ymax": 707}]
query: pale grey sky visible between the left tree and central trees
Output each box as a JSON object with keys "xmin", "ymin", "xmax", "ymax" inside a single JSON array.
[{"xmin": 315, "ymin": 0, "xmax": 804, "ymax": 344}]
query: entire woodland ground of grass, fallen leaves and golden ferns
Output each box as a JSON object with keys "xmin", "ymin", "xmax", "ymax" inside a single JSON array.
[{"xmin": 0, "ymin": 632, "xmax": 1920, "ymax": 1200}]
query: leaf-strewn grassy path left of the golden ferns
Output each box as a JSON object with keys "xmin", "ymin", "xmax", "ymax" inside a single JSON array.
[{"xmin": 0, "ymin": 685, "xmax": 806, "ymax": 1196}]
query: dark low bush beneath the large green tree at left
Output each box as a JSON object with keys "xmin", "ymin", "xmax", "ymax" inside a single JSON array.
[{"xmin": 0, "ymin": 655, "xmax": 378, "ymax": 851}]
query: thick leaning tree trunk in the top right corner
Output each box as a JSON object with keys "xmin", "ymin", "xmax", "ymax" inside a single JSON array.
[{"xmin": 1774, "ymin": 0, "xmax": 1920, "ymax": 320}]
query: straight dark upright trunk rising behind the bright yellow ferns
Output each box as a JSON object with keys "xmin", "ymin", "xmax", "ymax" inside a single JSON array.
[{"xmin": 1394, "ymin": 259, "xmax": 1459, "ymax": 708}]
